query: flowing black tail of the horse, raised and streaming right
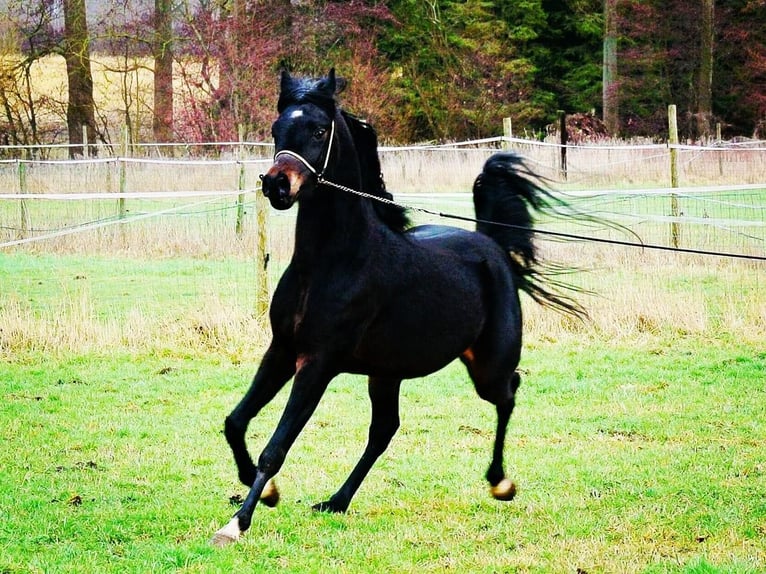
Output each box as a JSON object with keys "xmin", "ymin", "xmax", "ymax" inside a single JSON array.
[{"xmin": 473, "ymin": 152, "xmax": 587, "ymax": 318}]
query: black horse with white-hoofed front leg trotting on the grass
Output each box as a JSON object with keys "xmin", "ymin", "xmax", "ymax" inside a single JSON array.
[{"xmin": 213, "ymin": 70, "xmax": 581, "ymax": 545}]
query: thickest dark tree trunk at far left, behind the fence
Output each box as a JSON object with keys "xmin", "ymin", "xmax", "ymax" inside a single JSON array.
[{"xmin": 64, "ymin": 0, "xmax": 96, "ymax": 157}]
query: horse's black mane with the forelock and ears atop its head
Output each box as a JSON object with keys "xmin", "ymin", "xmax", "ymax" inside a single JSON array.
[{"xmin": 277, "ymin": 69, "xmax": 410, "ymax": 231}]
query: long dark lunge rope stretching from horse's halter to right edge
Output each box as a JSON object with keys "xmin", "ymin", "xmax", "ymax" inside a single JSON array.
[{"xmin": 318, "ymin": 177, "xmax": 766, "ymax": 261}]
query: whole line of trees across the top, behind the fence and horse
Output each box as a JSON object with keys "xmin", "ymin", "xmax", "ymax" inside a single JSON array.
[{"xmin": 0, "ymin": 0, "xmax": 766, "ymax": 154}]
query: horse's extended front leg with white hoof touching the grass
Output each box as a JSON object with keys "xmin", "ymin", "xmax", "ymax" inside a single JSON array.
[{"xmin": 212, "ymin": 356, "xmax": 337, "ymax": 546}]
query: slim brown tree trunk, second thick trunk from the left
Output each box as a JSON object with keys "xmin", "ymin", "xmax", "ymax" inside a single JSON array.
[{"xmin": 152, "ymin": 0, "xmax": 173, "ymax": 143}]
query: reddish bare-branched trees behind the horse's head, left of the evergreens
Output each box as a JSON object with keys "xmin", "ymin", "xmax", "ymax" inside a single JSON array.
[{"xmin": 176, "ymin": 0, "xmax": 400, "ymax": 141}]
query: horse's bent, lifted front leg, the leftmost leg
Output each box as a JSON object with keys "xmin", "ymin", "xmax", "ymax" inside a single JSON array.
[{"xmin": 224, "ymin": 343, "xmax": 295, "ymax": 496}]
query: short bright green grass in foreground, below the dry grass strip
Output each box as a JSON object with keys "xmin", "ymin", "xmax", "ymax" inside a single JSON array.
[{"xmin": 0, "ymin": 339, "xmax": 766, "ymax": 573}]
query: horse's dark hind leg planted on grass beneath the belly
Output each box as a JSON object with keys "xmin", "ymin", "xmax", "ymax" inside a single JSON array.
[{"xmin": 313, "ymin": 377, "xmax": 402, "ymax": 512}]
